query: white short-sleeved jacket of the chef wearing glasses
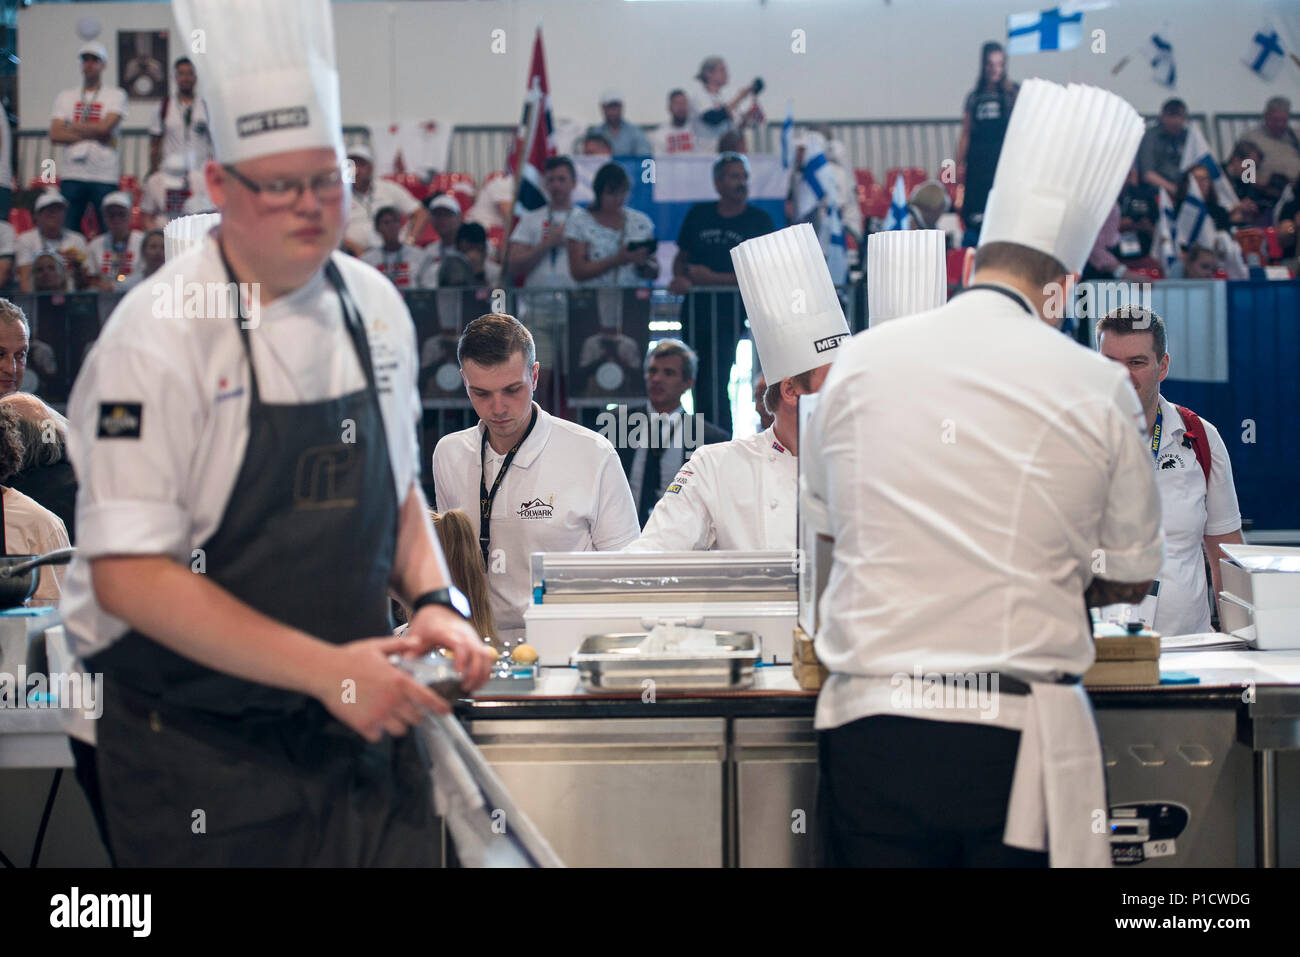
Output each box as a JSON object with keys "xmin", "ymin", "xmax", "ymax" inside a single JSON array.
[{"xmin": 62, "ymin": 239, "xmax": 421, "ymax": 654}]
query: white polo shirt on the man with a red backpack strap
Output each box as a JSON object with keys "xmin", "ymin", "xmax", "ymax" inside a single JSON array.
[{"xmin": 1147, "ymin": 395, "xmax": 1242, "ymax": 635}]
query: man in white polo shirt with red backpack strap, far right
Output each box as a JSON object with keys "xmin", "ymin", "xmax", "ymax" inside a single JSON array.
[{"xmin": 1097, "ymin": 306, "xmax": 1244, "ymax": 635}]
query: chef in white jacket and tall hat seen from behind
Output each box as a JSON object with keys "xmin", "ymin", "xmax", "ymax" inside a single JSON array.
[{"xmin": 803, "ymin": 79, "xmax": 1162, "ymax": 866}]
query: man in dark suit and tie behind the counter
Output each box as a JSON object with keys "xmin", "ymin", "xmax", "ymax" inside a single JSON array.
[{"xmin": 615, "ymin": 339, "xmax": 731, "ymax": 528}]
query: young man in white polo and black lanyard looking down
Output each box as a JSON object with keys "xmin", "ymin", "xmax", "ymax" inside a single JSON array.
[{"xmin": 433, "ymin": 313, "xmax": 640, "ymax": 641}]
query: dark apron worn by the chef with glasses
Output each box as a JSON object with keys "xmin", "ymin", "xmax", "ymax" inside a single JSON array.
[{"xmin": 87, "ymin": 254, "xmax": 437, "ymax": 867}]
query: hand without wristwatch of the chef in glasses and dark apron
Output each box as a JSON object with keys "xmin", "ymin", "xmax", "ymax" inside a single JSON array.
[{"xmin": 316, "ymin": 636, "xmax": 451, "ymax": 741}]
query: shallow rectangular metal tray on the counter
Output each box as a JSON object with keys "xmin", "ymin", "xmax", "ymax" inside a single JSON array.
[{"xmin": 569, "ymin": 632, "xmax": 759, "ymax": 692}]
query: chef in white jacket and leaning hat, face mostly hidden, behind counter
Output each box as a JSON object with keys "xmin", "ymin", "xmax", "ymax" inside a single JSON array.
[{"xmin": 627, "ymin": 222, "xmax": 849, "ymax": 553}]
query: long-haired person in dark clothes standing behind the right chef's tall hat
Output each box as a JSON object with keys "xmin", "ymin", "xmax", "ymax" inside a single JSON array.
[{"xmin": 957, "ymin": 43, "xmax": 1019, "ymax": 246}]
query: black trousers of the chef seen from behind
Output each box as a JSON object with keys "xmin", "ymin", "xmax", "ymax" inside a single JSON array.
[{"xmin": 818, "ymin": 715, "xmax": 1048, "ymax": 867}]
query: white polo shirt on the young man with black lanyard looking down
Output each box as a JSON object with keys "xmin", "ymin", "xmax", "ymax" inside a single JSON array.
[{"xmin": 433, "ymin": 403, "xmax": 641, "ymax": 640}]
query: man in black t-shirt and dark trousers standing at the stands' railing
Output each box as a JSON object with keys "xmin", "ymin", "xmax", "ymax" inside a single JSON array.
[{"xmin": 668, "ymin": 153, "xmax": 775, "ymax": 433}]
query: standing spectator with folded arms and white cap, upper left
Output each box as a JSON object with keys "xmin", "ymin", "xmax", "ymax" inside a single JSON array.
[{"xmin": 49, "ymin": 42, "xmax": 126, "ymax": 237}]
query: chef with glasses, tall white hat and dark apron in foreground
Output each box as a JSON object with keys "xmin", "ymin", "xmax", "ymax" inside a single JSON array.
[{"xmin": 62, "ymin": 0, "xmax": 490, "ymax": 866}]
